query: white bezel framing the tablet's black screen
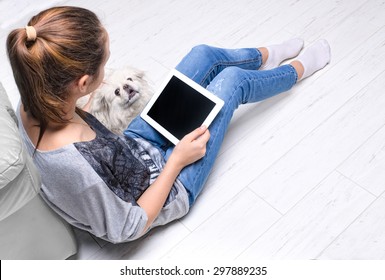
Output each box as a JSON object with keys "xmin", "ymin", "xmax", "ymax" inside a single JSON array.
[{"xmin": 140, "ymin": 69, "xmax": 224, "ymax": 145}]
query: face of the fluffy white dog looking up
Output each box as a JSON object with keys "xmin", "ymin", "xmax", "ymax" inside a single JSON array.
[{"xmin": 100, "ymin": 69, "xmax": 145, "ymax": 109}]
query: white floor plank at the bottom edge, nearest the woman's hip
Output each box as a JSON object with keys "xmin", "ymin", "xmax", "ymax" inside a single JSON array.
[{"xmin": 162, "ymin": 189, "xmax": 281, "ymax": 260}]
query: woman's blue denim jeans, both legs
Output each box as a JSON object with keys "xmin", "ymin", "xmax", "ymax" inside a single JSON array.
[{"xmin": 124, "ymin": 45, "xmax": 297, "ymax": 206}]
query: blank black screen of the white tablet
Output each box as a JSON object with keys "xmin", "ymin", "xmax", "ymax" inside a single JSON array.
[{"xmin": 148, "ymin": 76, "xmax": 215, "ymax": 140}]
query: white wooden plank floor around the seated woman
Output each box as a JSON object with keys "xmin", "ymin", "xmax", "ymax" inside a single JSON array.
[{"xmin": 0, "ymin": 0, "xmax": 385, "ymax": 260}]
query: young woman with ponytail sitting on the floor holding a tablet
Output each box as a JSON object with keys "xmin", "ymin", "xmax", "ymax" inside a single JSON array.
[{"xmin": 7, "ymin": 7, "xmax": 330, "ymax": 243}]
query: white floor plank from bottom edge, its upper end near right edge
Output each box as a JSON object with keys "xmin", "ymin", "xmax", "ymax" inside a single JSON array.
[{"xmin": 239, "ymin": 172, "xmax": 375, "ymax": 259}]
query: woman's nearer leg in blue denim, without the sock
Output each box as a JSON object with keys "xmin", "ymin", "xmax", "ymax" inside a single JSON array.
[{"xmin": 173, "ymin": 65, "xmax": 298, "ymax": 205}]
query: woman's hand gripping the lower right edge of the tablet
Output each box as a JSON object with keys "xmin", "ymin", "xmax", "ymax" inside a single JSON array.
[{"xmin": 168, "ymin": 126, "xmax": 210, "ymax": 169}]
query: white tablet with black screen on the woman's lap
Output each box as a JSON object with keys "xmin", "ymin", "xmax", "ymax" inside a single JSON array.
[{"xmin": 140, "ymin": 69, "xmax": 224, "ymax": 145}]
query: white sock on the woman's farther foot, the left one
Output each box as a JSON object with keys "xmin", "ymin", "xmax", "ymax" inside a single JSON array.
[{"xmin": 260, "ymin": 38, "xmax": 303, "ymax": 70}]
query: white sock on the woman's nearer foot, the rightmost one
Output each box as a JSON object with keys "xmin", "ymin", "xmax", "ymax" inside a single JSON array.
[{"xmin": 296, "ymin": 39, "xmax": 331, "ymax": 80}]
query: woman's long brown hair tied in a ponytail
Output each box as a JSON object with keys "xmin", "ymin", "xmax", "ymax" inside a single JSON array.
[{"xmin": 7, "ymin": 6, "xmax": 106, "ymax": 148}]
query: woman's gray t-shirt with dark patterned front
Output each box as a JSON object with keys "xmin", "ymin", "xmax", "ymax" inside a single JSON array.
[{"xmin": 17, "ymin": 110, "xmax": 189, "ymax": 243}]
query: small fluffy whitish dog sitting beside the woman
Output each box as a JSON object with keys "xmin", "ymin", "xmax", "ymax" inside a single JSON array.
[{"xmin": 77, "ymin": 67, "xmax": 152, "ymax": 134}]
